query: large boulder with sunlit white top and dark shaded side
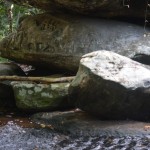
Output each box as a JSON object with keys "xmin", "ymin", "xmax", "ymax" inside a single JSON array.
[{"xmin": 69, "ymin": 50, "xmax": 150, "ymax": 120}]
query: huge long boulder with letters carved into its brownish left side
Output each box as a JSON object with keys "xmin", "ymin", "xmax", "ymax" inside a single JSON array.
[{"xmin": 0, "ymin": 13, "xmax": 150, "ymax": 72}]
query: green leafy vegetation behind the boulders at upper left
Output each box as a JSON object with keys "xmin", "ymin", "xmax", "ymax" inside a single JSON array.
[{"xmin": 0, "ymin": 0, "xmax": 41, "ymax": 62}]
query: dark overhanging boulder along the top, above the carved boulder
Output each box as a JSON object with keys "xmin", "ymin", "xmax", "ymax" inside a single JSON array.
[{"xmin": 12, "ymin": 0, "xmax": 147, "ymax": 18}]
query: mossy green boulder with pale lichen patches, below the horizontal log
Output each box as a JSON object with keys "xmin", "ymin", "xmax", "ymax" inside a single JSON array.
[{"xmin": 11, "ymin": 82, "xmax": 70, "ymax": 112}]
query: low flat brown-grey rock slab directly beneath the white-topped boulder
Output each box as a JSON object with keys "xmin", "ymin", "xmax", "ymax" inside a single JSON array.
[{"xmin": 31, "ymin": 111, "xmax": 150, "ymax": 137}]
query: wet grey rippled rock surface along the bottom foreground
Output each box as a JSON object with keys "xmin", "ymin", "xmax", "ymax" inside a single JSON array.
[{"xmin": 0, "ymin": 122, "xmax": 150, "ymax": 150}]
